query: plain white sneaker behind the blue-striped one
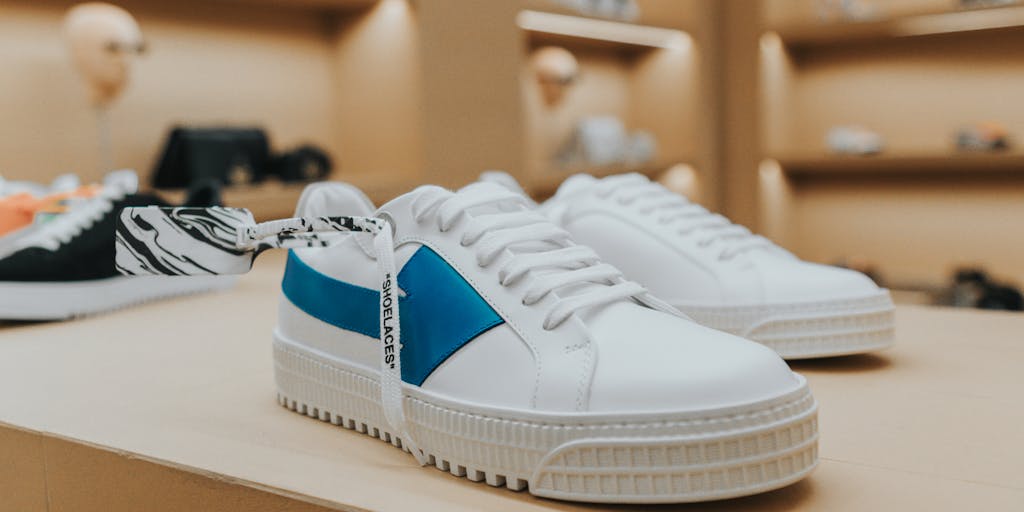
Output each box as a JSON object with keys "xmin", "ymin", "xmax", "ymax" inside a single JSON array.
[{"xmin": 541, "ymin": 174, "xmax": 894, "ymax": 358}]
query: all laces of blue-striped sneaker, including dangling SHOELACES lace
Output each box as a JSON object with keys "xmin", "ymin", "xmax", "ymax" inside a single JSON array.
[{"xmin": 226, "ymin": 187, "xmax": 655, "ymax": 465}]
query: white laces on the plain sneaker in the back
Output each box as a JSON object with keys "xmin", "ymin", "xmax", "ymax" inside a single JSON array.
[{"xmin": 594, "ymin": 174, "xmax": 776, "ymax": 261}]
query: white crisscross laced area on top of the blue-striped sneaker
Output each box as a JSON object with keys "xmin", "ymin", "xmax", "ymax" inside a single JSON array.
[{"xmin": 412, "ymin": 184, "xmax": 647, "ymax": 331}]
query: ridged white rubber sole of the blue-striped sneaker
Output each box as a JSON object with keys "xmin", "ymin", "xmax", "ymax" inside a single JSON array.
[{"xmin": 273, "ymin": 333, "xmax": 818, "ymax": 503}]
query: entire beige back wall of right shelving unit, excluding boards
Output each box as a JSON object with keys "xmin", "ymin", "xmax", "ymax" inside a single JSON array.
[{"xmin": 751, "ymin": 0, "xmax": 1024, "ymax": 286}]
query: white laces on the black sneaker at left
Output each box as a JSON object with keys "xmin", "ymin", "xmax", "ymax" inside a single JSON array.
[{"xmin": 28, "ymin": 183, "xmax": 134, "ymax": 251}]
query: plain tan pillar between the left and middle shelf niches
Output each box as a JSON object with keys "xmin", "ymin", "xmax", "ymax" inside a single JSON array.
[{"xmin": 417, "ymin": 0, "xmax": 525, "ymax": 186}]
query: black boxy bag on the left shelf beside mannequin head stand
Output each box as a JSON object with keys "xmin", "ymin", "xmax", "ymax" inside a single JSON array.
[{"xmin": 153, "ymin": 127, "xmax": 270, "ymax": 188}]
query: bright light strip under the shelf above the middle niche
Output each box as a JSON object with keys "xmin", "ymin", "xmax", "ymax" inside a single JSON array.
[{"xmin": 516, "ymin": 10, "xmax": 691, "ymax": 49}]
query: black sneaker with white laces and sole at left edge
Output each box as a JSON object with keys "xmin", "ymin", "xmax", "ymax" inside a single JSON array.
[{"xmin": 0, "ymin": 171, "xmax": 234, "ymax": 321}]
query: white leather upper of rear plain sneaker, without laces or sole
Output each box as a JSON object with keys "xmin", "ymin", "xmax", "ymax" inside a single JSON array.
[{"xmin": 542, "ymin": 176, "xmax": 880, "ymax": 307}]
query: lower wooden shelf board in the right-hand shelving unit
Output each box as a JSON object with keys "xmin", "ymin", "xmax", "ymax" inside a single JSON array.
[{"xmin": 775, "ymin": 152, "xmax": 1024, "ymax": 175}]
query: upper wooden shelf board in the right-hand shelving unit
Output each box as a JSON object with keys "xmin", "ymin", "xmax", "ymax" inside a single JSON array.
[{"xmin": 768, "ymin": 6, "xmax": 1024, "ymax": 47}]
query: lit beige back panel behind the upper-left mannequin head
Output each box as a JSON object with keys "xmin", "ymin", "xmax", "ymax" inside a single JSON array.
[{"xmin": 0, "ymin": 0, "xmax": 338, "ymax": 187}]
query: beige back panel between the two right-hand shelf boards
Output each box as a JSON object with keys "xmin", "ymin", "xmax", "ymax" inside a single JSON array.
[{"xmin": 782, "ymin": 33, "xmax": 1024, "ymax": 155}]
